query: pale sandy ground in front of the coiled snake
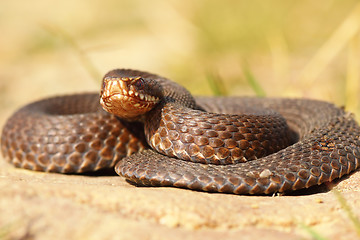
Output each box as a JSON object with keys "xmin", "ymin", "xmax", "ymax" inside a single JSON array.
[{"xmin": 0, "ymin": 155, "xmax": 360, "ymax": 239}]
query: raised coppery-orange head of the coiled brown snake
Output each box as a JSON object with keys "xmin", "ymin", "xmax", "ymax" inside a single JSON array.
[{"xmin": 100, "ymin": 70, "xmax": 162, "ymax": 120}]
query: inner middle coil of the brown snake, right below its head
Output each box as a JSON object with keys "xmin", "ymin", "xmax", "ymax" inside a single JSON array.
[{"xmin": 145, "ymin": 103, "xmax": 295, "ymax": 165}]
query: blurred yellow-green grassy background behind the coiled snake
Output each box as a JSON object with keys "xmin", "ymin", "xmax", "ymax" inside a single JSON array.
[{"xmin": 0, "ymin": 0, "xmax": 360, "ymax": 124}]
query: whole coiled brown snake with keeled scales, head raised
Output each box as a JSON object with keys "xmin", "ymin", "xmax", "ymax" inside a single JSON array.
[{"xmin": 1, "ymin": 69, "xmax": 360, "ymax": 195}]
